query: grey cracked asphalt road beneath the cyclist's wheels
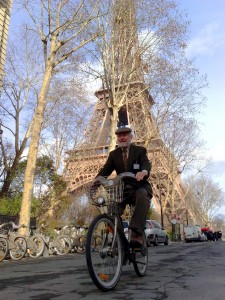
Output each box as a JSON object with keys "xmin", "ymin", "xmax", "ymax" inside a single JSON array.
[{"xmin": 0, "ymin": 241, "xmax": 225, "ymax": 300}]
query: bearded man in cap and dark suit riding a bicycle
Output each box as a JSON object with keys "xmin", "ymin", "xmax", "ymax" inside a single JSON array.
[{"xmin": 97, "ymin": 127, "xmax": 152, "ymax": 247}]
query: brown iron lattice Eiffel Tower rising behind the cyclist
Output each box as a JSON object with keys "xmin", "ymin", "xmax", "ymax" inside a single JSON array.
[{"xmin": 65, "ymin": 0, "xmax": 197, "ymax": 225}]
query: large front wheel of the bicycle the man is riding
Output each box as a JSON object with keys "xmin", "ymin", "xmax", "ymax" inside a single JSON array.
[{"xmin": 86, "ymin": 215, "xmax": 123, "ymax": 291}]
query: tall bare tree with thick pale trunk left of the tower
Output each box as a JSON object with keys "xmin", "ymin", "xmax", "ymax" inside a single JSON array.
[{"xmin": 17, "ymin": 0, "xmax": 99, "ymax": 232}]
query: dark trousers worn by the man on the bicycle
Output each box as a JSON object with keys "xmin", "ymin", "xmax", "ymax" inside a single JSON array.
[{"xmin": 118, "ymin": 185, "xmax": 151, "ymax": 235}]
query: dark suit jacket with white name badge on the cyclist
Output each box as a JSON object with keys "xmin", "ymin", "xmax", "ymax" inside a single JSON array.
[{"xmin": 97, "ymin": 144, "xmax": 152, "ymax": 195}]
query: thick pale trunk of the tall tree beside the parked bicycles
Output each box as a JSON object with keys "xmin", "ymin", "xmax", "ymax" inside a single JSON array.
[{"xmin": 19, "ymin": 63, "xmax": 53, "ymax": 234}]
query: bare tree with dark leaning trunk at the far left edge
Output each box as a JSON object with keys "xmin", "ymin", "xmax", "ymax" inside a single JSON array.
[{"xmin": 0, "ymin": 29, "xmax": 40, "ymax": 197}]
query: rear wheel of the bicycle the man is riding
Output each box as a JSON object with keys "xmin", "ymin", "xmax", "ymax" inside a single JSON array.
[{"xmin": 132, "ymin": 234, "xmax": 148, "ymax": 277}]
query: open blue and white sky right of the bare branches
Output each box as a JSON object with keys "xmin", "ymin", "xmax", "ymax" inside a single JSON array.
[{"xmin": 177, "ymin": 0, "xmax": 225, "ymax": 215}]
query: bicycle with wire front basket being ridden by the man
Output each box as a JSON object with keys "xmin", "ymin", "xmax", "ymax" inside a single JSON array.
[{"xmin": 86, "ymin": 172, "xmax": 148, "ymax": 292}]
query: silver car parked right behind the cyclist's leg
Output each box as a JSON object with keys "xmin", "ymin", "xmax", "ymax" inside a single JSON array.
[{"xmin": 145, "ymin": 220, "xmax": 168, "ymax": 246}]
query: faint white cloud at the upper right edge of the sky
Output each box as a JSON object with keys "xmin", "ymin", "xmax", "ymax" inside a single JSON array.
[{"xmin": 187, "ymin": 22, "xmax": 224, "ymax": 56}]
